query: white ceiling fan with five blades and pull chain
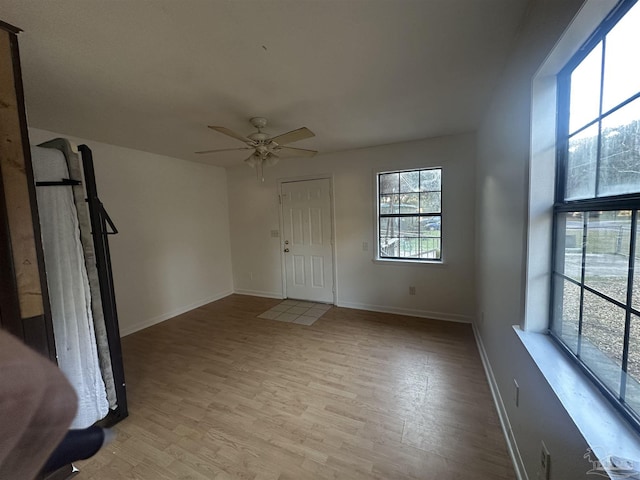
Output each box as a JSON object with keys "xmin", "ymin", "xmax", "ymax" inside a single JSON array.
[{"xmin": 195, "ymin": 117, "xmax": 318, "ymax": 182}]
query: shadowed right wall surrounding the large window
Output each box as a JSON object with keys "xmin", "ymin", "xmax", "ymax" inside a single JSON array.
[{"xmin": 476, "ymin": 0, "xmax": 597, "ymax": 480}]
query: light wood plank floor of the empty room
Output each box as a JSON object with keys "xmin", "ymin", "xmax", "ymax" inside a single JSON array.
[{"xmin": 76, "ymin": 295, "xmax": 515, "ymax": 480}]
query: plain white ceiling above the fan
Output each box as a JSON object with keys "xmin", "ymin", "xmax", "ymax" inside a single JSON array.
[{"xmin": 0, "ymin": 0, "xmax": 527, "ymax": 166}]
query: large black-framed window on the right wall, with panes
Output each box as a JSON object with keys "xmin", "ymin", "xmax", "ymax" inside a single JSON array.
[{"xmin": 550, "ymin": 0, "xmax": 640, "ymax": 429}]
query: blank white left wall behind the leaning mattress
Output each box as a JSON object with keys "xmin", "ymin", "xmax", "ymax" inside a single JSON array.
[{"xmin": 29, "ymin": 128, "xmax": 233, "ymax": 335}]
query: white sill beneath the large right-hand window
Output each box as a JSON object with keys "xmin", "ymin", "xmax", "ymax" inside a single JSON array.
[{"xmin": 513, "ymin": 325, "xmax": 640, "ymax": 478}]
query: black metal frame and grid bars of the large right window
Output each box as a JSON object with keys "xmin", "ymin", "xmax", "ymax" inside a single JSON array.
[{"xmin": 549, "ymin": 0, "xmax": 640, "ymax": 431}]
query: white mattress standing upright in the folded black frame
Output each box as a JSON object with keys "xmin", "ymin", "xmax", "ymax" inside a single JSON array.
[{"xmin": 31, "ymin": 147, "xmax": 109, "ymax": 428}]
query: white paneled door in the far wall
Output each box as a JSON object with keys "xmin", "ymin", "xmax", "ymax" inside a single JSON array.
[{"xmin": 281, "ymin": 178, "xmax": 333, "ymax": 303}]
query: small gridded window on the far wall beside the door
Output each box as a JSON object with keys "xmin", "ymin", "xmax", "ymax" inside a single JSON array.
[{"xmin": 377, "ymin": 168, "xmax": 442, "ymax": 261}]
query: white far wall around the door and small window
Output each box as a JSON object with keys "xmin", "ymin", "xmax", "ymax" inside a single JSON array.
[{"xmin": 227, "ymin": 134, "xmax": 476, "ymax": 321}]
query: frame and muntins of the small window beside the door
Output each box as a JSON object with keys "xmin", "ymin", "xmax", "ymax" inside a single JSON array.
[{"xmin": 374, "ymin": 166, "xmax": 444, "ymax": 265}]
